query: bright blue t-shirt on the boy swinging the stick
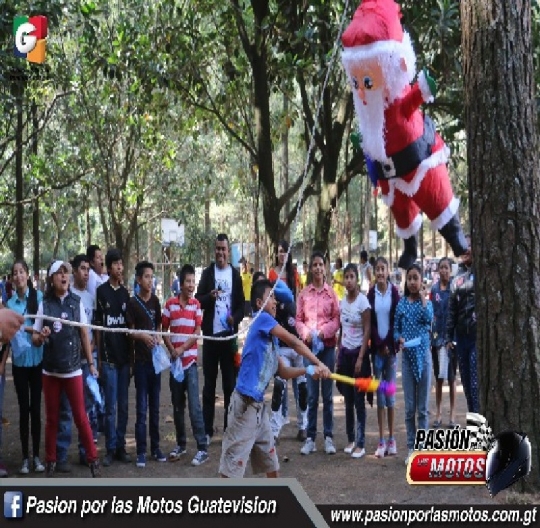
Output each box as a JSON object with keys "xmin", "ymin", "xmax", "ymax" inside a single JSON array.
[{"xmin": 236, "ymin": 312, "xmax": 278, "ymax": 402}]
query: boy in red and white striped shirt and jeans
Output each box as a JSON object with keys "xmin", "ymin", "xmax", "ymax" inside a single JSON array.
[{"xmin": 161, "ymin": 264, "xmax": 208, "ymax": 466}]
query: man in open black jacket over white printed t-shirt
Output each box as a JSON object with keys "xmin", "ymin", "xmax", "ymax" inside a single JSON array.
[{"xmin": 195, "ymin": 234, "xmax": 244, "ymax": 444}]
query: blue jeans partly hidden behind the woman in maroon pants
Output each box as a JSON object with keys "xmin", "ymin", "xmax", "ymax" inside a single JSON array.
[{"xmin": 56, "ymin": 364, "xmax": 101, "ymax": 463}]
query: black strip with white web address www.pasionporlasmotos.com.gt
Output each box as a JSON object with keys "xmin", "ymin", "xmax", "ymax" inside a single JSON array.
[{"xmin": 317, "ymin": 504, "xmax": 540, "ymax": 528}]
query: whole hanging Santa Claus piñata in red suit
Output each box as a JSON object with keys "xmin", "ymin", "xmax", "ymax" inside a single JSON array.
[{"xmin": 342, "ymin": 0, "xmax": 468, "ymax": 269}]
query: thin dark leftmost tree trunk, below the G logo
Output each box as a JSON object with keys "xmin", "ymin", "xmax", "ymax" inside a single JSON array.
[{"xmin": 15, "ymin": 82, "xmax": 24, "ymax": 259}]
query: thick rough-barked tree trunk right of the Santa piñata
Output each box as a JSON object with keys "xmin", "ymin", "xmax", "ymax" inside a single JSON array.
[{"xmin": 460, "ymin": 0, "xmax": 540, "ymax": 490}]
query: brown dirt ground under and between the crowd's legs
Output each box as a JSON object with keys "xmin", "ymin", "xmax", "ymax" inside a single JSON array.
[{"xmin": 2, "ymin": 344, "xmax": 539, "ymax": 505}]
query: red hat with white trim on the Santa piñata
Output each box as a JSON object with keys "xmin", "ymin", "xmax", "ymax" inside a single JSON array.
[{"xmin": 341, "ymin": 0, "xmax": 416, "ymax": 80}]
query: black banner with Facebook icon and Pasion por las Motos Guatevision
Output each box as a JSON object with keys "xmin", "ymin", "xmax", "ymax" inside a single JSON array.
[{"xmin": 0, "ymin": 479, "xmax": 325, "ymax": 528}]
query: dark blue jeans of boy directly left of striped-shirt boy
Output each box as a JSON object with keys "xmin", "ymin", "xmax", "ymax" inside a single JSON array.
[{"xmin": 134, "ymin": 361, "xmax": 161, "ymax": 455}]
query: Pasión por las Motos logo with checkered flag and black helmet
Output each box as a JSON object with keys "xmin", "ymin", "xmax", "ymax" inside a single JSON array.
[{"xmin": 407, "ymin": 413, "xmax": 531, "ymax": 497}]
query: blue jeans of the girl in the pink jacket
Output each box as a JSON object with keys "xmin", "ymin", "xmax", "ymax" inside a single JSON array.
[{"xmin": 304, "ymin": 347, "xmax": 336, "ymax": 441}]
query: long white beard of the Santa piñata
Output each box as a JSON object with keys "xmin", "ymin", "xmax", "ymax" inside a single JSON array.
[{"xmin": 353, "ymin": 90, "xmax": 386, "ymax": 162}]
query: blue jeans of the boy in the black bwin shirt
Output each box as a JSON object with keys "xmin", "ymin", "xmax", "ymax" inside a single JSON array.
[{"xmin": 101, "ymin": 361, "xmax": 129, "ymax": 453}]
